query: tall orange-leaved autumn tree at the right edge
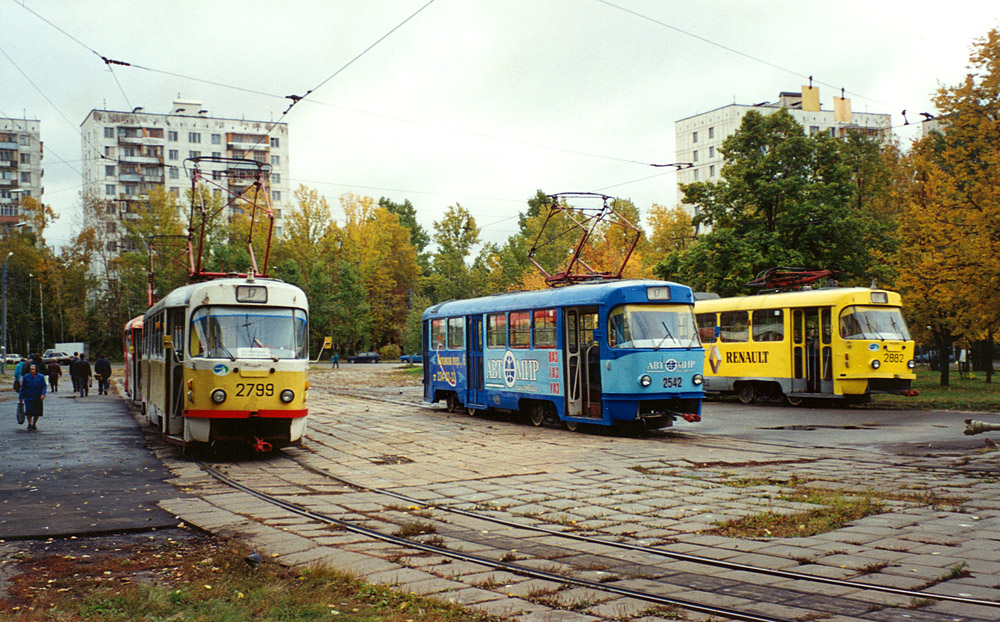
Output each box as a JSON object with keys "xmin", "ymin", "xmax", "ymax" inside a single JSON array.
[{"xmin": 899, "ymin": 29, "xmax": 1000, "ymax": 384}]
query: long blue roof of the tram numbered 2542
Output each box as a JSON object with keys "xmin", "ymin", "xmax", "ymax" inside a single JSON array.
[{"xmin": 423, "ymin": 280, "xmax": 694, "ymax": 319}]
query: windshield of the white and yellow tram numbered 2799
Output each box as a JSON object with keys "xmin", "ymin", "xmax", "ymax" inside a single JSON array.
[{"xmin": 189, "ymin": 307, "xmax": 309, "ymax": 360}]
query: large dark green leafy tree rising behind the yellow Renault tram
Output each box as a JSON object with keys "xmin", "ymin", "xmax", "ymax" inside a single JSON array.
[{"xmin": 656, "ymin": 109, "xmax": 895, "ymax": 295}]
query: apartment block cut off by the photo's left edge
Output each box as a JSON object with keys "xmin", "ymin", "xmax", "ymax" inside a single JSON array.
[{"xmin": 0, "ymin": 118, "xmax": 45, "ymax": 234}]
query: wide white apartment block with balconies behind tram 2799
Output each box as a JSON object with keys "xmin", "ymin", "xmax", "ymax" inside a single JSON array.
[{"xmin": 81, "ymin": 99, "xmax": 293, "ymax": 251}]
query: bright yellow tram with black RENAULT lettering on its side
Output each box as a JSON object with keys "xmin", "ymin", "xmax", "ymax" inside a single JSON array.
[{"xmin": 695, "ymin": 288, "xmax": 916, "ymax": 404}]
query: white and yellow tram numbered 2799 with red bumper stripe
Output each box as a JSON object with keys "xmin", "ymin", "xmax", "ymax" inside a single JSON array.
[{"xmin": 140, "ymin": 277, "xmax": 309, "ymax": 451}]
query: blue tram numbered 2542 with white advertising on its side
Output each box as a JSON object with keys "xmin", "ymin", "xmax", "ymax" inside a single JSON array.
[{"xmin": 423, "ymin": 281, "xmax": 705, "ymax": 430}]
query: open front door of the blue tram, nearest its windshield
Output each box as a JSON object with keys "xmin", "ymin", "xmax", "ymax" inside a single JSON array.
[{"xmin": 563, "ymin": 309, "xmax": 602, "ymax": 419}]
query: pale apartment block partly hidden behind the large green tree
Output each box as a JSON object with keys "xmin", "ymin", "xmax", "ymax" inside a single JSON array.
[{"xmin": 674, "ymin": 86, "xmax": 892, "ymax": 214}]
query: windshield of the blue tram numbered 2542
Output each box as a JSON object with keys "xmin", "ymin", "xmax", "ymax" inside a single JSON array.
[{"xmin": 608, "ymin": 305, "xmax": 701, "ymax": 349}]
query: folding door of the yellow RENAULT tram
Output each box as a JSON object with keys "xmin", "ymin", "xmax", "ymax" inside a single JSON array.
[{"xmin": 792, "ymin": 307, "xmax": 833, "ymax": 393}]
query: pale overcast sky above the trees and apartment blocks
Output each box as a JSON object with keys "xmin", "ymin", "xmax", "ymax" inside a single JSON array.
[{"xmin": 0, "ymin": 0, "xmax": 1000, "ymax": 251}]
